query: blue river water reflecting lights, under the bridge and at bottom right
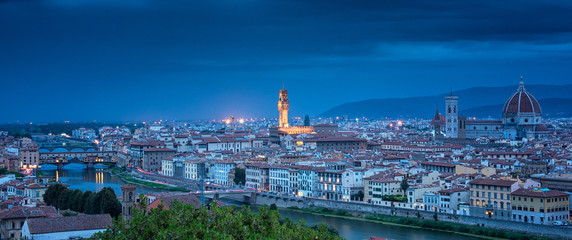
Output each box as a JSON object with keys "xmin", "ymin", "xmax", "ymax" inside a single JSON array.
[{"xmin": 42, "ymin": 165, "xmax": 479, "ymax": 240}]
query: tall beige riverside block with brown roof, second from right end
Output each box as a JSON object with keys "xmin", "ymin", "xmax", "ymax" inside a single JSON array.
[{"xmin": 469, "ymin": 178, "xmax": 519, "ymax": 220}]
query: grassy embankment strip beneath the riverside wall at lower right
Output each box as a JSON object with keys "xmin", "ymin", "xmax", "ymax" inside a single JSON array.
[{"xmin": 285, "ymin": 207, "xmax": 551, "ymax": 240}]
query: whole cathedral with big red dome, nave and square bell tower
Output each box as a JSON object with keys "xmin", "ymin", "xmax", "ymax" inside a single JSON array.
[{"xmin": 431, "ymin": 77, "xmax": 548, "ymax": 139}]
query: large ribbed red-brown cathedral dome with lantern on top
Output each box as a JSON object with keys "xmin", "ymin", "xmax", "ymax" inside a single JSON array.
[{"xmin": 502, "ymin": 78, "xmax": 542, "ymax": 116}]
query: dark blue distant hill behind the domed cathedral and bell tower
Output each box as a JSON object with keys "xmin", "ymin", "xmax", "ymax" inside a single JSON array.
[{"xmin": 321, "ymin": 84, "xmax": 572, "ymax": 118}]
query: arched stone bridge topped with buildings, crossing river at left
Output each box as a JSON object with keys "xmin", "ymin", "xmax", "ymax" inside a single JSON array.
[{"xmin": 40, "ymin": 151, "xmax": 117, "ymax": 169}]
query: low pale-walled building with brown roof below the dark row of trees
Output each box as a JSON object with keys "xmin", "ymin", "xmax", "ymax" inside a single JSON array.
[{"xmin": 22, "ymin": 214, "xmax": 113, "ymax": 240}]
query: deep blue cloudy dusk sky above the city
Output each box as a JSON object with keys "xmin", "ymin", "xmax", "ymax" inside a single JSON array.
[{"xmin": 0, "ymin": 0, "xmax": 572, "ymax": 123}]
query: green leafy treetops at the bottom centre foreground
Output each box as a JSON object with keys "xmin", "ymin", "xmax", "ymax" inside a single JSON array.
[{"xmin": 92, "ymin": 197, "xmax": 341, "ymax": 239}]
